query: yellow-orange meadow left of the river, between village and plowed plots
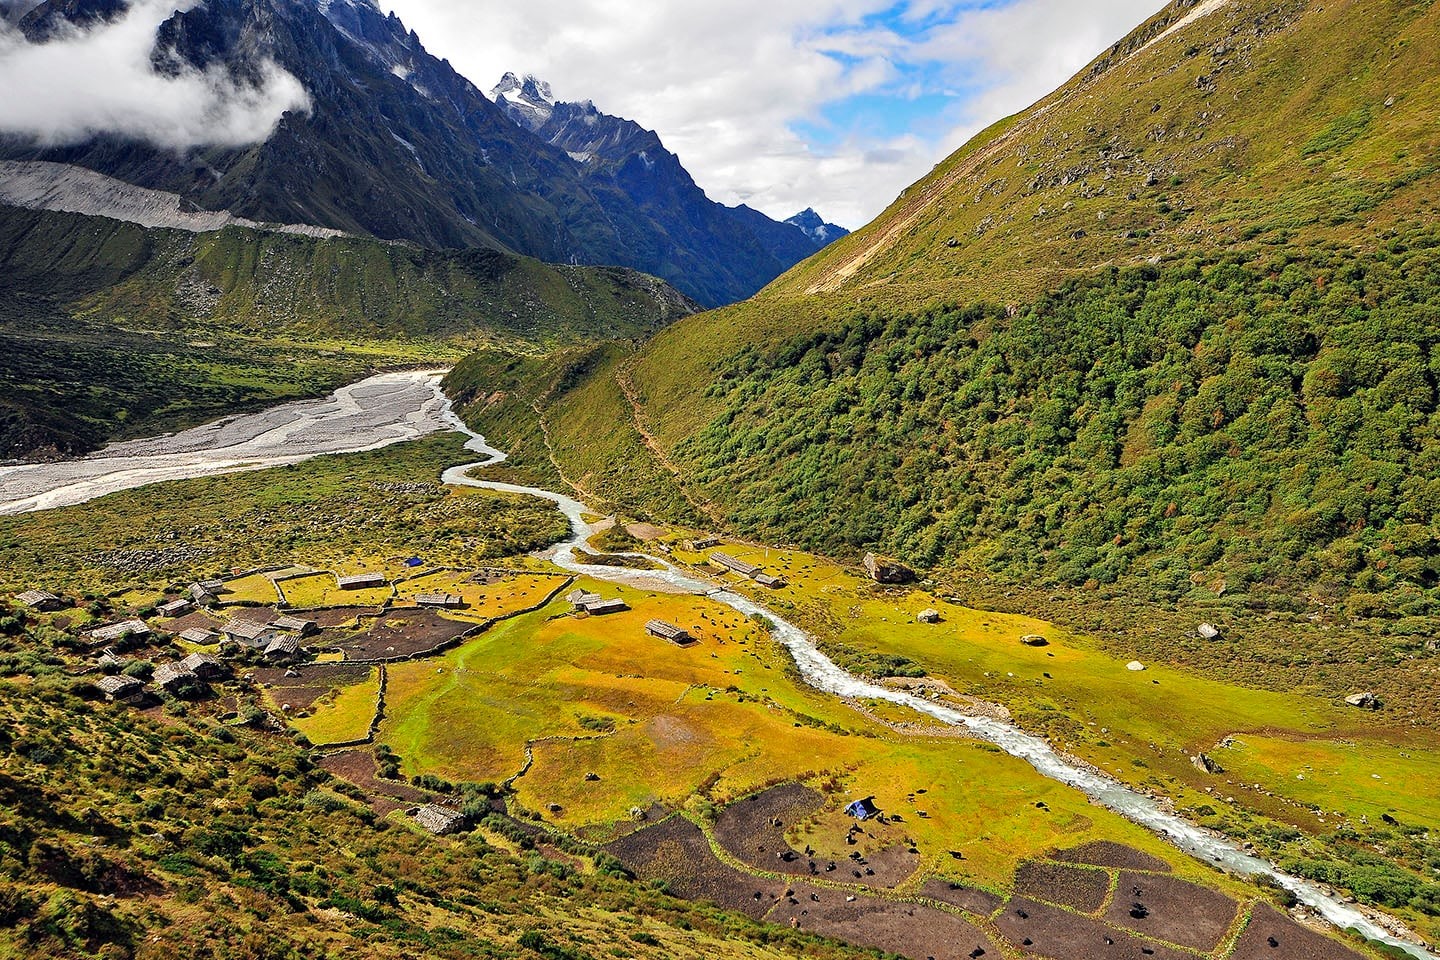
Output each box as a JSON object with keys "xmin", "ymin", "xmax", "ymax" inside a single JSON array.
[{"xmin": 380, "ymin": 581, "xmax": 1244, "ymax": 887}]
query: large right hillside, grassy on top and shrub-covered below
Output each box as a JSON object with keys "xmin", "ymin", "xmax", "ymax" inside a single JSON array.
[{"xmin": 452, "ymin": 0, "xmax": 1440, "ymax": 667}]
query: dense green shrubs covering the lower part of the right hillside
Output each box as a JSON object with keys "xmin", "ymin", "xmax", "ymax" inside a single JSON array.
[{"xmin": 675, "ymin": 241, "xmax": 1440, "ymax": 632}]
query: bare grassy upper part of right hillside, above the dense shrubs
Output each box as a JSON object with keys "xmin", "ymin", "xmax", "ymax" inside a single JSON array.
[{"xmin": 762, "ymin": 0, "xmax": 1440, "ymax": 304}]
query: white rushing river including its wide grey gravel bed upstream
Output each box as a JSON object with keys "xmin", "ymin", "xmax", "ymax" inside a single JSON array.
[{"xmin": 0, "ymin": 373, "xmax": 1437, "ymax": 960}]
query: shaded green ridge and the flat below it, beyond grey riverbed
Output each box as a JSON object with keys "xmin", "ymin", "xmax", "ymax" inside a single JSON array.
[{"xmin": 0, "ymin": 207, "xmax": 691, "ymax": 458}]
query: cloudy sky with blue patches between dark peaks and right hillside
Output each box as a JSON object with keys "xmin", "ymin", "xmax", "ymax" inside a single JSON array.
[{"xmin": 380, "ymin": 0, "xmax": 1162, "ymax": 226}]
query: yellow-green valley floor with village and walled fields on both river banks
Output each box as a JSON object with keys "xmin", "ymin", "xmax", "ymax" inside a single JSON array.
[{"xmin": 0, "ymin": 385, "xmax": 1440, "ymax": 959}]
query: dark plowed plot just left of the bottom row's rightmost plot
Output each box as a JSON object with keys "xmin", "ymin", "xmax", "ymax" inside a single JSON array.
[{"xmin": 1106, "ymin": 872, "xmax": 1240, "ymax": 951}]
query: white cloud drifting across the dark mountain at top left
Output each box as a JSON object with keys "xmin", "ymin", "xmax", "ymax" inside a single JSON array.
[{"xmin": 0, "ymin": 0, "xmax": 310, "ymax": 150}]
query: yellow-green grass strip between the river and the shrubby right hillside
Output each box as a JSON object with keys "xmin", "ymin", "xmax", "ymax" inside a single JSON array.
[{"xmin": 699, "ymin": 544, "xmax": 1440, "ymax": 828}]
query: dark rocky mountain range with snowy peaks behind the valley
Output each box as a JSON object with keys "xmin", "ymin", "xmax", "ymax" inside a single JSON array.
[{"xmin": 0, "ymin": 0, "xmax": 838, "ymax": 305}]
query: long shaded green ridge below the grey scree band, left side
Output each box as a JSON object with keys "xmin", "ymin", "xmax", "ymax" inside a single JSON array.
[{"xmin": 0, "ymin": 207, "xmax": 691, "ymax": 345}]
